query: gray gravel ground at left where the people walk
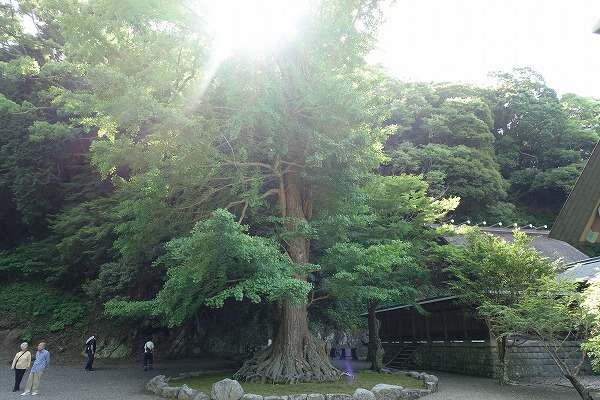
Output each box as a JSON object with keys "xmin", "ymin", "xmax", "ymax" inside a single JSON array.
[{"xmin": 0, "ymin": 360, "xmax": 234, "ymax": 400}]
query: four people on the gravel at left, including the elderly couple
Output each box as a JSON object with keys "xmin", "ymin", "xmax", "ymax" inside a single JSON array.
[{"xmin": 11, "ymin": 335, "xmax": 154, "ymax": 396}]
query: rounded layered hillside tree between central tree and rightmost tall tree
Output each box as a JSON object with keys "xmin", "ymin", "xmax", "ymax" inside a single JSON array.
[{"xmin": 383, "ymin": 81, "xmax": 507, "ymax": 218}]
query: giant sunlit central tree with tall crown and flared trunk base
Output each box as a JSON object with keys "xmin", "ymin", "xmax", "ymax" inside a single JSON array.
[{"xmin": 51, "ymin": 0, "xmax": 392, "ymax": 382}]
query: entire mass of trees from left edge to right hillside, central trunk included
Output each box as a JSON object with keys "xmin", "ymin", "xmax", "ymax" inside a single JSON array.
[{"xmin": 0, "ymin": 0, "xmax": 600, "ymax": 381}]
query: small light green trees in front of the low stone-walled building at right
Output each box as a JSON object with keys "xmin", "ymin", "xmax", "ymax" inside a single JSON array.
[{"xmin": 449, "ymin": 230, "xmax": 592, "ymax": 390}]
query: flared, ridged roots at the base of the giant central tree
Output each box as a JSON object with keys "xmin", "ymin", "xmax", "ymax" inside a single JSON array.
[{"xmin": 234, "ymin": 333, "xmax": 342, "ymax": 383}]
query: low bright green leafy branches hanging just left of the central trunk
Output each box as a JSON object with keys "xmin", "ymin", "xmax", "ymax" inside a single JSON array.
[{"xmin": 106, "ymin": 210, "xmax": 316, "ymax": 326}]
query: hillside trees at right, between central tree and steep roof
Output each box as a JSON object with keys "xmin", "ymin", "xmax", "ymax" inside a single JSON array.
[{"xmin": 385, "ymin": 68, "xmax": 600, "ymax": 224}]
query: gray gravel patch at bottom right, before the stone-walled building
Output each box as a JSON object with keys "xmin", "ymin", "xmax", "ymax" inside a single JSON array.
[{"xmin": 423, "ymin": 372, "xmax": 580, "ymax": 400}]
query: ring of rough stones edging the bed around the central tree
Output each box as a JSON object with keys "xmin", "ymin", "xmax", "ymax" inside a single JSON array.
[{"xmin": 145, "ymin": 371, "xmax": 438, "ymax": 400}]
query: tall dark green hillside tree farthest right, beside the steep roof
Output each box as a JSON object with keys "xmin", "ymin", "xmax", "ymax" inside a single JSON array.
[{"xmin": 491, "ymin": 68, "xmax": 600, "ymax": 224}]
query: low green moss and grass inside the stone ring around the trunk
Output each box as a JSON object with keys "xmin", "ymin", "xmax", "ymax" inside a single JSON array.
[{"xmin": 178, "ymin": 371, "xmax": 423, "ymax": 396}]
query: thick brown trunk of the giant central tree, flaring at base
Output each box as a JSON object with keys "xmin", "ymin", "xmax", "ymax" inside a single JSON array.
[{"xmin": 234, "ymin": 166, "xmax": 341, "ymax": 383}]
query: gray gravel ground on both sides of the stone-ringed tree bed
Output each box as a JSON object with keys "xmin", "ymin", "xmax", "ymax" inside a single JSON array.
[{"xmin": 0, "ymin": 360, "xmax": 579, "ymax": 400}]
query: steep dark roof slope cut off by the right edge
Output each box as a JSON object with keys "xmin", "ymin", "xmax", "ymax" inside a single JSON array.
[{"xmin": 550, "ymin": 144, "xmax": 600, "ymax": 245}]
